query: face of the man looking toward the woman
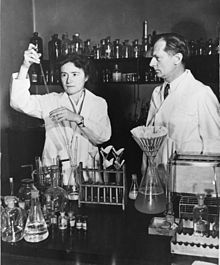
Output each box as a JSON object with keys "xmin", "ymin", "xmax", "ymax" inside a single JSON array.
[{"xmin": 150, "ymin": 40, "xmax": 177, "ymax": 82}]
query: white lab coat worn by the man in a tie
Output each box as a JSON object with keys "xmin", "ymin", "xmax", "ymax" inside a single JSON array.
[{"xmin": 142, "ymin": 70, "xmax": 220, "ymax": 170}]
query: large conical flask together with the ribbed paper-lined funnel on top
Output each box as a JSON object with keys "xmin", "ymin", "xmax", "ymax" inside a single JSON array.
[{"xmin": 131, "ymin": 126, "xmax": 167, "ymax": 214}]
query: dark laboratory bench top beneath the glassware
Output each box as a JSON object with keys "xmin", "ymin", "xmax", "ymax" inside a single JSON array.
[{"xmin": 1, "ymin": 199, "xmax": 217, "ymax": 265}]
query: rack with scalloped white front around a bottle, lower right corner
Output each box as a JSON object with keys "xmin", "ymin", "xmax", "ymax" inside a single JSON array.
[{"xmin": 171, "ymin": 195, "xmax": 219, "ymax": 258}]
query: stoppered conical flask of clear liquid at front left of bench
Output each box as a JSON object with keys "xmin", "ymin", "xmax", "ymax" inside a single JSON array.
[{"xmin": 24, "ymin": 190, "xmax": 49, "ymax": 243}]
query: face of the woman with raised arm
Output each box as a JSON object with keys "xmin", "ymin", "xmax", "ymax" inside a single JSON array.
[{"xmin": 61, "ymin": 62, "xmax": 88, "ymax": 95}]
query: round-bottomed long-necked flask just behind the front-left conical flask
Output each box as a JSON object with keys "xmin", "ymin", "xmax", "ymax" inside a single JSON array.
[{"xmin": 44, "ymin": 165, "xmax": 67, "ymax": 212}]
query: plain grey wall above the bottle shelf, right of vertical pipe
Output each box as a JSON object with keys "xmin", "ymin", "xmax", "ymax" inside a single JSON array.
[{"xmin": 35, "ymin": 0, "xmax": 220, "ymax": 57}]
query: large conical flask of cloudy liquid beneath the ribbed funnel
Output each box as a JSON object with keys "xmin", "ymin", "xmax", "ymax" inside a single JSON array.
[{"xmin": 135, "ymin": 156, "xmax": 166, "ymax": 214}]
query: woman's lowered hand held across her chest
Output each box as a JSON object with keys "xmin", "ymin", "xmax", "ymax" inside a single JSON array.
[{"xmin": 50, "ymin": 107, "xmax": 81, "ymax": 123}]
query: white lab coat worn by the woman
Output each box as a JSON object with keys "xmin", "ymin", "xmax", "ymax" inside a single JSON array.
[{"xmin": 10, "ymin": 73, "xmax": 111, "ymax": 184}]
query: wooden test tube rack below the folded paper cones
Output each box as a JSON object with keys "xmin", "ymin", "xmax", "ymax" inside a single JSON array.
[{"xmin": 78, "ymin": 163, "xmax": 126, "ymax": 210}]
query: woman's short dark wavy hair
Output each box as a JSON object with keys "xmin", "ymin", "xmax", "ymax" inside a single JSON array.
[{"xmin": 57, "ymin": 53, "xmax": 96, "ymax": 90}]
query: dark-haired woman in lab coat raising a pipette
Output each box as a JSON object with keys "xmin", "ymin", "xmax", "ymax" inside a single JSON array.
[{"xmin": 10, "ymin": 44, "xmax": 111, "ymax": 185}]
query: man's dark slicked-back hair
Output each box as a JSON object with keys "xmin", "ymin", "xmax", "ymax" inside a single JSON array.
[{"xmin": 153, "ymin": 33, "xmax": 190, "ymax": 65}]
